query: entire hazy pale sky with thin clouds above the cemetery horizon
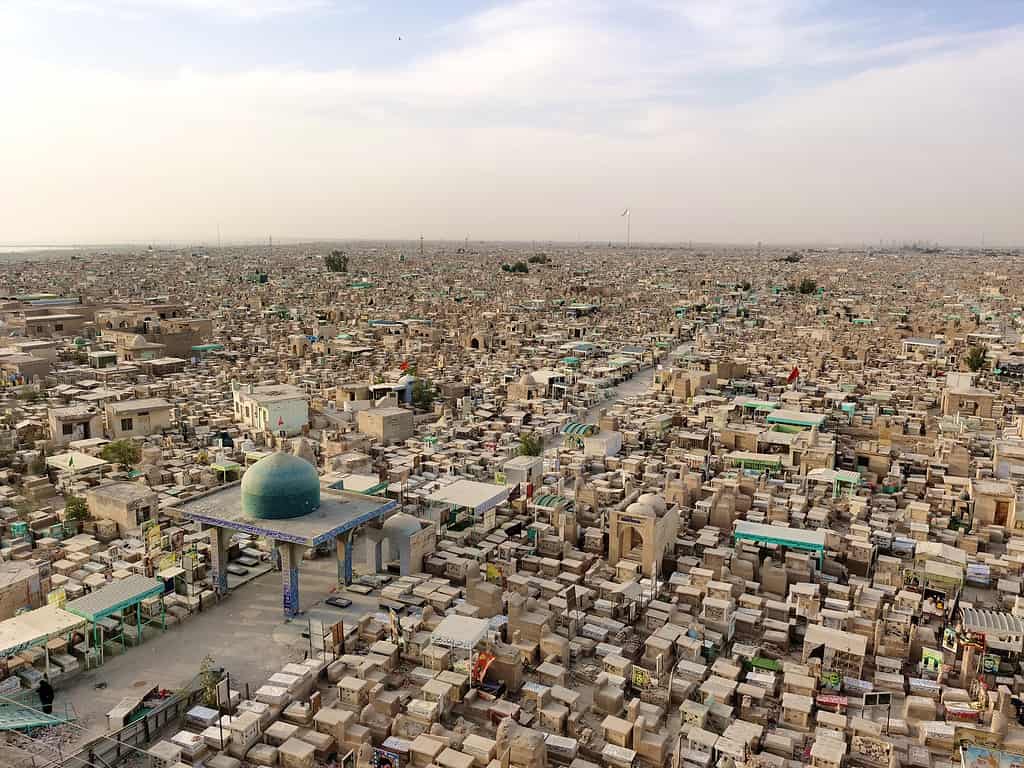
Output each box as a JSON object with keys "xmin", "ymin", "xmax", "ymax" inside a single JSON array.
[{"xmin": 0, "ymin": 0, "xmax": 1024, "ymax": 244}]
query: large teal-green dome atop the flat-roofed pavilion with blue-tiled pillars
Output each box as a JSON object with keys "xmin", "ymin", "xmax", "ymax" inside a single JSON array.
[{"xmin": 242, "ymin": 453, "xmax": 319, "ymax": 520}]
